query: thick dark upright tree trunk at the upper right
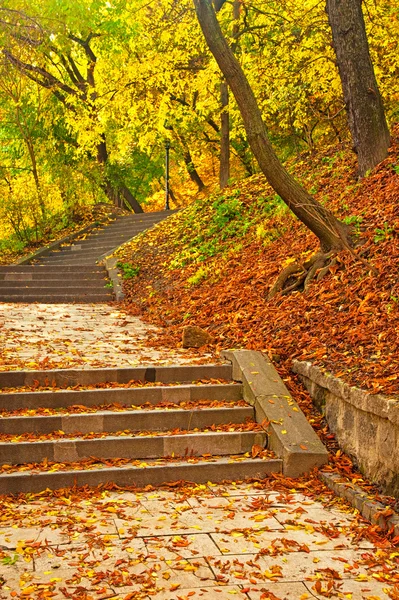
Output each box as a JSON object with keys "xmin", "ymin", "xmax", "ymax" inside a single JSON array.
[{"xmin": 326, "ymin": 0, "xmax": 390, "ymax": 177}]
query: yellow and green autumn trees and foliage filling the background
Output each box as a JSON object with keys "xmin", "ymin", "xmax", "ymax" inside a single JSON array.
[{"xmin": 0, "ymin": 0, "xmax": 399, "ymax": 255}]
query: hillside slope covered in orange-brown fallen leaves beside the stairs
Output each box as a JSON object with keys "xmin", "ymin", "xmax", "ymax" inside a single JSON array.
[{"xmin": 115, "ymin": 129, "xmax": 399, "ymax": 394}]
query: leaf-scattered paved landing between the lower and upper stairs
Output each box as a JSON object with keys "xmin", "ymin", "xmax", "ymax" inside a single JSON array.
[{"xmin": 0, "ymin": 303, "xmax": 211, "ymax": 370}]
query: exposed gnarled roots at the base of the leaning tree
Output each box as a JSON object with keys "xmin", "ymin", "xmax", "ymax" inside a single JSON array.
[{"xmin": 267, "ymin": 251, "xmax": 337, "ymax": 300}]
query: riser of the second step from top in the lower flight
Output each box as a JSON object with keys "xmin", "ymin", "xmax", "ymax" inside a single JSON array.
[{"xmin": 0, "ymin": 384, "xmax": 242, "ymax": 412}]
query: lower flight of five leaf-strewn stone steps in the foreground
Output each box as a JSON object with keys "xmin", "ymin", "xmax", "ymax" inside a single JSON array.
[{"xmin": 0, "ymin": 365, "xmax": 282, "ymax": 494}]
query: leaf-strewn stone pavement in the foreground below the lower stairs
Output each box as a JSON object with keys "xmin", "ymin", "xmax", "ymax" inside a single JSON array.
[{"xmin": 0, "ymin": 483, "xmax": 399, "ymax": 600}]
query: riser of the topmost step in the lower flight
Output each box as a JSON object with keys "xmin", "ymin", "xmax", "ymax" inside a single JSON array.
[{"xmin": 0, "ymin": 364, "xmax": 233, "ymax": 390}]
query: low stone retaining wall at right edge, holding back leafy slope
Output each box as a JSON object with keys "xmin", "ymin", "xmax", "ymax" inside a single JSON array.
[{"xmin": 293, "ymin": 360, "xmax": 399, "ymax": 497}]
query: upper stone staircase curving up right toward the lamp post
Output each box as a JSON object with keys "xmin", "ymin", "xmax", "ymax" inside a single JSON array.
[{"xmin": 0, "ymin": 211, "xmax": 171, "ymax": 304}]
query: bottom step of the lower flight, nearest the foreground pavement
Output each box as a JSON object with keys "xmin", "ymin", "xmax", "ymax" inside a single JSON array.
[{"xmin": 0, "ymin": 455, "xmax": 283, "ymax": 494}]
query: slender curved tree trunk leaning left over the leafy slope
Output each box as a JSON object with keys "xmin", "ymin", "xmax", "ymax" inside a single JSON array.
[{"xmin": 194, "ymin": 0, "xmax": 348, "ymax": 252}]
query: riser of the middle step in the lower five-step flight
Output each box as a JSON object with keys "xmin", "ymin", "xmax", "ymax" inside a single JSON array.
[{"xmin": 0, "ymin": 406, "xmax": 254, "ymax": 435}]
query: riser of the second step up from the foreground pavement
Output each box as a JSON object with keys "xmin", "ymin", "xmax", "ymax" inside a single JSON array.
[{"xmin": 0, "ymin": 432, "xmax": 266, "ymax": 465}]
